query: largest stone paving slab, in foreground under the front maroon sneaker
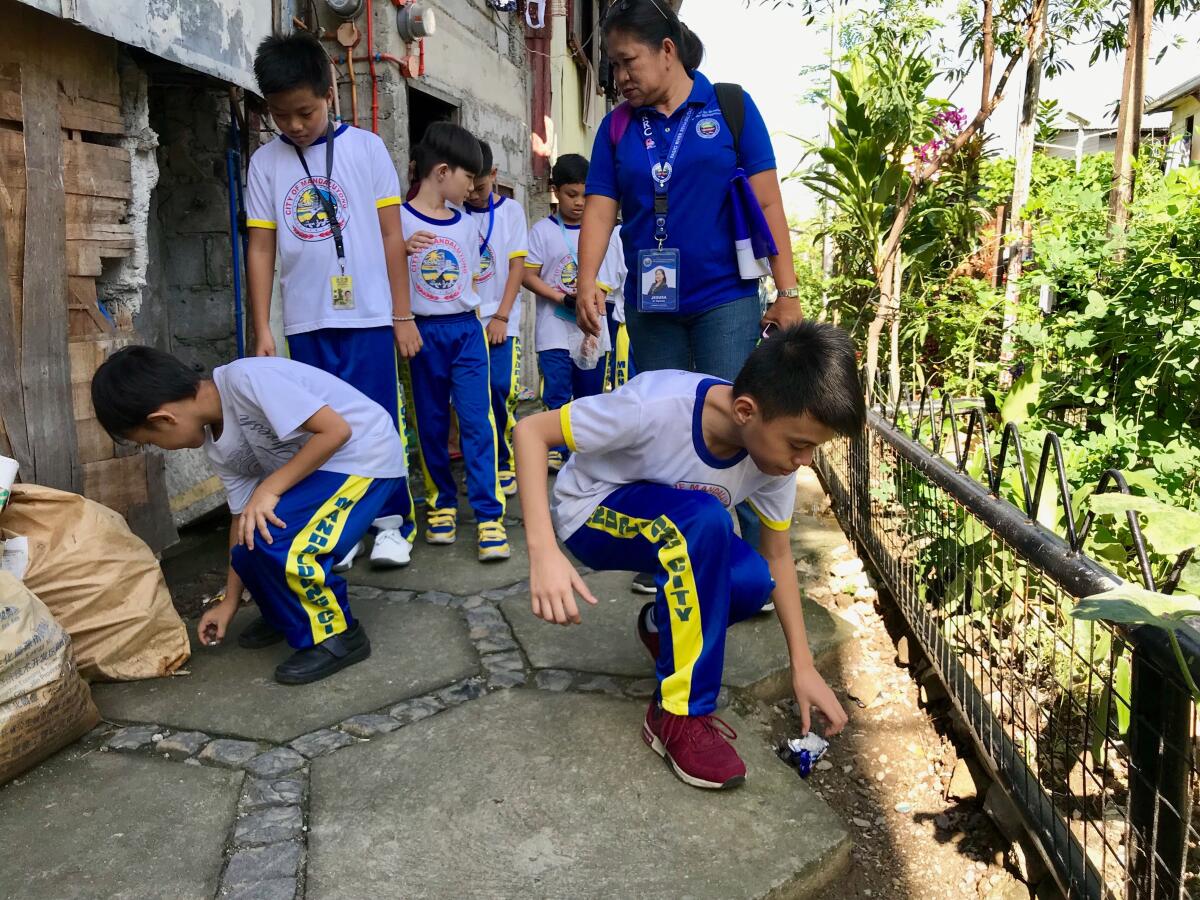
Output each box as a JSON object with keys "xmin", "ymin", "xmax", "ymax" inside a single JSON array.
[{"xmin": 307, "ymin": 690, "xmax": 850, "ymax": 900}]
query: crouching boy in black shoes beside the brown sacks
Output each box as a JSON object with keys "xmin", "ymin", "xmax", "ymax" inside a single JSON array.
[{"xmin": 91, "ymin": 347, "xmax": 407, "ymax": 684}]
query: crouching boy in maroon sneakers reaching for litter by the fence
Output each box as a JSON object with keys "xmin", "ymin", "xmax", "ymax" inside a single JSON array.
[{"xmin": 516, "ymin": 323, "xmax": 866, "ymax": 787}]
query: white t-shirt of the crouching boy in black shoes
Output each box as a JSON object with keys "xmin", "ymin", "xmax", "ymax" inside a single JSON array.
[{"xmin": 204, "ymin": 356, "xmax": 408, "ymax": 515}]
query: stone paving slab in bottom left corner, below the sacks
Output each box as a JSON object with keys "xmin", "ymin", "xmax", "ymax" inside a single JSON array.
[{"xmin": 0, "ymin": 749, "xmax": 242, "ymax": 900}]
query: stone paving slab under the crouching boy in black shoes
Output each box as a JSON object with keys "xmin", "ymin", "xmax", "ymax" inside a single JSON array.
[{"xmin": 92, "ymin": 598, "xmax": 479, "ymax": 743}]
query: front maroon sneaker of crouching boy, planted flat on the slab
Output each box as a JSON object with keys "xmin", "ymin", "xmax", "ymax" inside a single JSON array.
[{"xmin": 642, "ymin": 698, "xmax": 746, "ymax": 788}]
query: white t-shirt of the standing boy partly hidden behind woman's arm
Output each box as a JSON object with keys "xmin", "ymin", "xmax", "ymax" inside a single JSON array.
[{"xmin": 526, "ymin": 216, "xmax": 624, "ymax": 353}]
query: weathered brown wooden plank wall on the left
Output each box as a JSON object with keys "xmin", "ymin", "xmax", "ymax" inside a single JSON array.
[{"xmin": 0, "ymin": 0, "xmax": 176, "ymax": 550}]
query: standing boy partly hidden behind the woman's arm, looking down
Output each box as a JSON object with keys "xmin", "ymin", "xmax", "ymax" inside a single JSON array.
[{"xmin": 524, "ymin": 154, "xmax": 624, "ymax": 469}]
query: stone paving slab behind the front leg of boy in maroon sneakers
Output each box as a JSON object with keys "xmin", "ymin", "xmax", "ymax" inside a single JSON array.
[{"xmin": 500, "ymin": 572, "xmax": 852, "ymax": 700}]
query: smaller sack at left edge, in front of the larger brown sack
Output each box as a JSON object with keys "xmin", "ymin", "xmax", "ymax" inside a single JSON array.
[{"xmin": 0, "ymin": 571, "xmax": 100, "ymax": 785}]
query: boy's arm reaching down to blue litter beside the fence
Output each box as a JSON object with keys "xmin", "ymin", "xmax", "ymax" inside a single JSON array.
[{"xmin": 758, "ymin": 528, "xmax": 848, "ymax": 734}]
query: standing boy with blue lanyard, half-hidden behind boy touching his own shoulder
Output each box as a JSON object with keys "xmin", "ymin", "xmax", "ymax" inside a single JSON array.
[{"xmin": 467, "ymin": 140, "xmax": 529, "ymax": 494}]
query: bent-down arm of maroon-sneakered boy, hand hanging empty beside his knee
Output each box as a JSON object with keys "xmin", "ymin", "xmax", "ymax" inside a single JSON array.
[{"xmin": 514, "ymin": 409, "xmax": 596, "ymax": 625}]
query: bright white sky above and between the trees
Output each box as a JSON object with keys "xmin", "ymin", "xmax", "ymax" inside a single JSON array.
[{"xmin": 679, "ymin": 0, "xmax": 1200, "ymax": 217}]
